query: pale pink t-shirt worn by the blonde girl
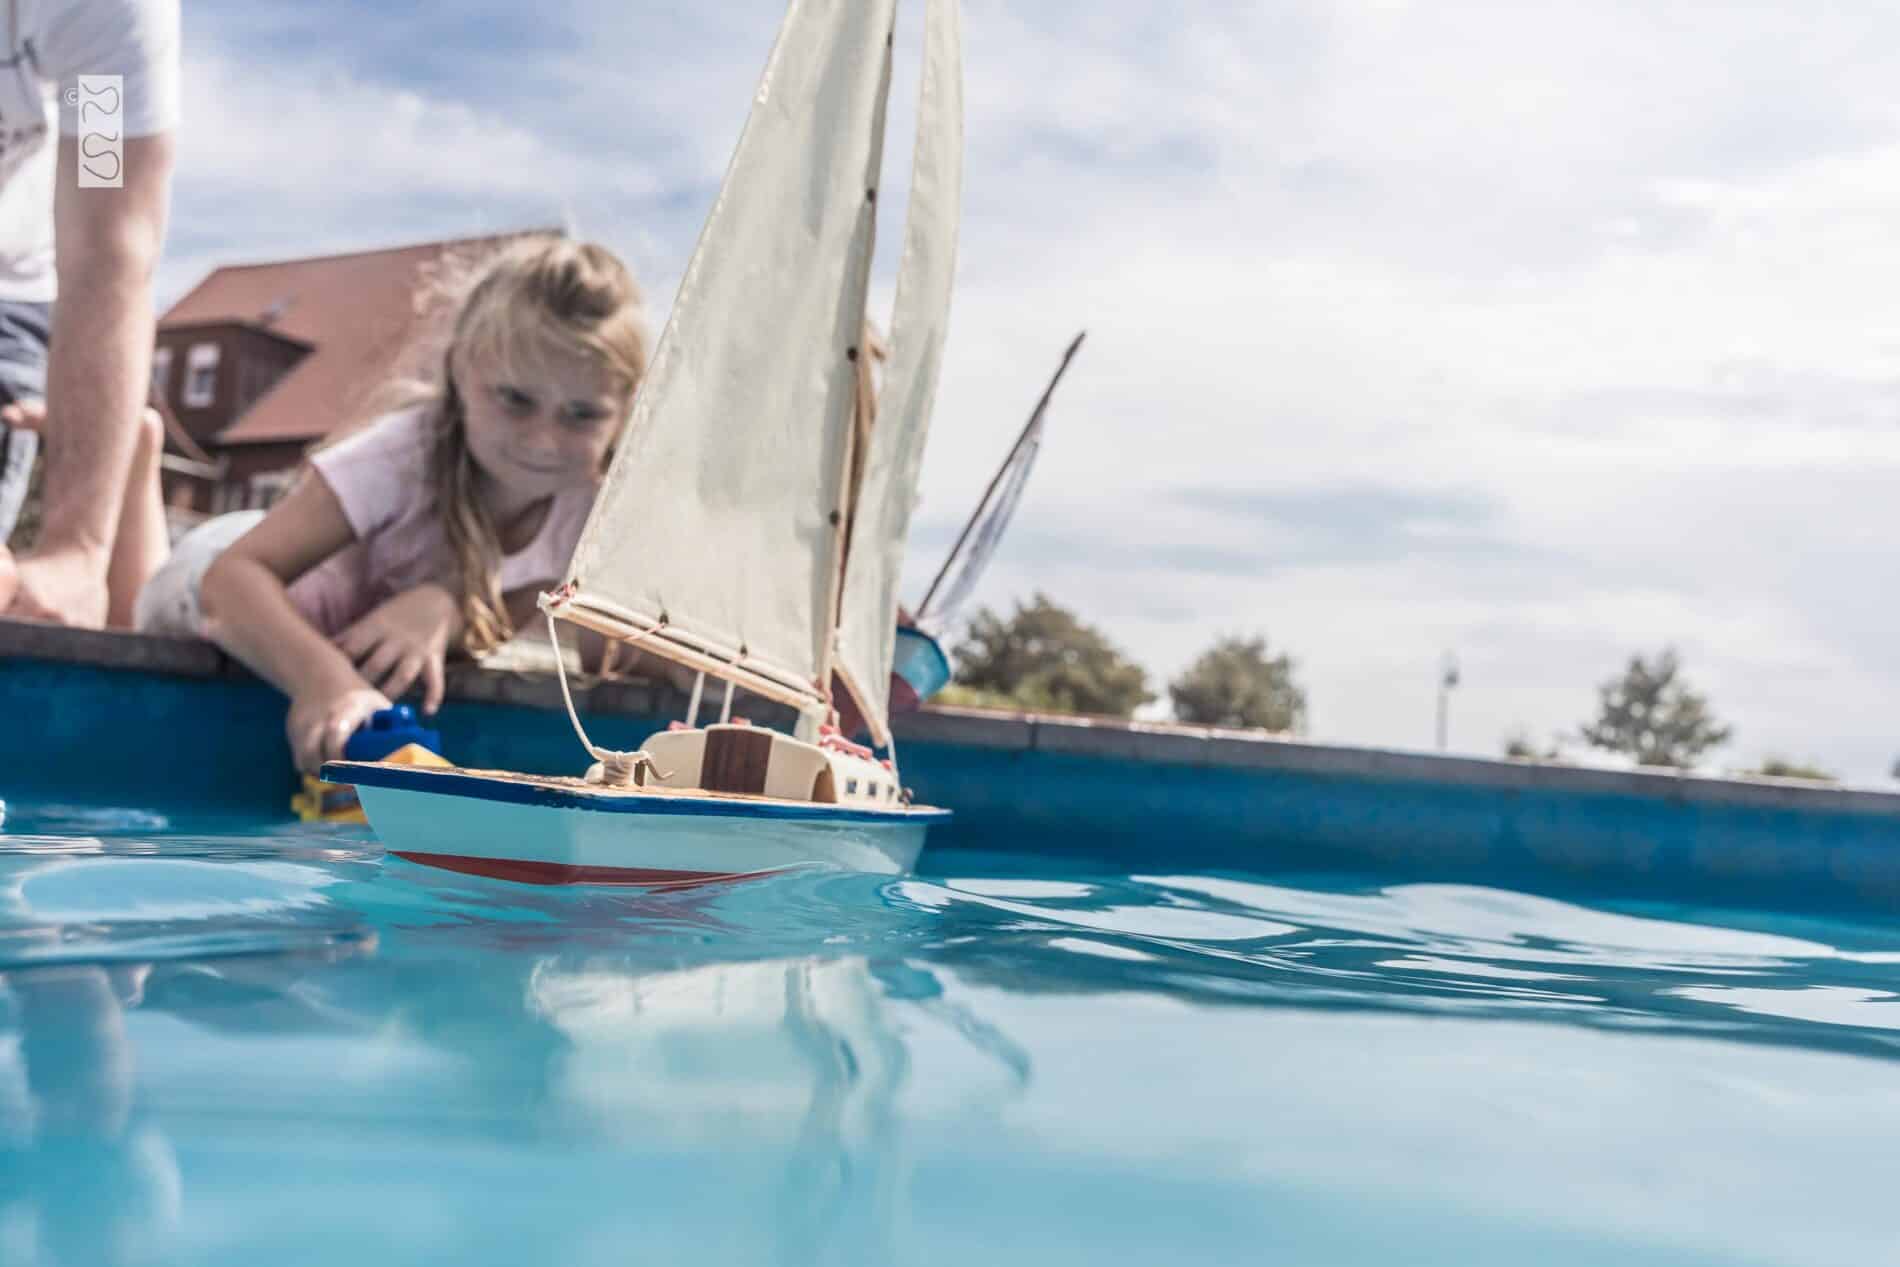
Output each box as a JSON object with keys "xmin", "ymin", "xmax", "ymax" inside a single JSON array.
[{"xmin": 291, "ymin": 408, "xmax": 595, "ymax": 636}]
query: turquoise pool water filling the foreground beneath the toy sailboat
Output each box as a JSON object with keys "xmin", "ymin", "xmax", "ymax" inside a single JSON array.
[{"xmin": 0, "ymin": 805, "xmax": 1900, "ymax": 1267}]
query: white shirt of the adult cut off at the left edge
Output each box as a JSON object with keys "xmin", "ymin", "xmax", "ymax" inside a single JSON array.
[{"xmin": 0, "ymin": 0, "xmax": 179, "ymax": 302}]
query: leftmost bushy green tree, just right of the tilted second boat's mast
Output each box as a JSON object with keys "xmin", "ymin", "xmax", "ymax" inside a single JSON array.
[{"xmin": 952, "ymin": 593, "xmax": 1155, "ymax": 718}]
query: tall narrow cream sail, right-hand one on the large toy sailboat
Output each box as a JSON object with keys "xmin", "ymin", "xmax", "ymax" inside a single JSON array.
[{"xmin": 838, "ymin": 0, "xmax": 963, "ymax": 745}]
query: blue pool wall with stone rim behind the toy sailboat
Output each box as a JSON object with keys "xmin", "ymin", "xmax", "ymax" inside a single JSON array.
[{"xmin": 11, "ymin": 621, "xmax": 1900, "ymax": 910}]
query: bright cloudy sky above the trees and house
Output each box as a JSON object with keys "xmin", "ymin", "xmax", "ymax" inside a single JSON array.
[{"xmin": 160, "ymin": 0, "xmax": 1900, "ymax": 783}]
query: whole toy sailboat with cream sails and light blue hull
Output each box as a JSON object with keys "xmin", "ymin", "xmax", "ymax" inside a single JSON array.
[{"xmin": 323, "ymin": 0, "xmax": 963, "ymax": 885}]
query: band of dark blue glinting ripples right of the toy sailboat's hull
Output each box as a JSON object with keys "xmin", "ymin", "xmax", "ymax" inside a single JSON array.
[{"xmin": 893, "ymin": 874, "xmax": 1900, "ymax": 1056}]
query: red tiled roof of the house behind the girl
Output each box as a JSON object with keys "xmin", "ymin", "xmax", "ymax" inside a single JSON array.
[{"xmin": 158, "ymin": 230, "xmax": 559, "ymax": 448}]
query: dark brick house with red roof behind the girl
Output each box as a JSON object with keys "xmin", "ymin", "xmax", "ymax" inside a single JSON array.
[{"xmin": 152, "ymin": 234, "xmax": 551, "ymax": 526}]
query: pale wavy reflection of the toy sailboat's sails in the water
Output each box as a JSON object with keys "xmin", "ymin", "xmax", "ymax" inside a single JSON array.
[{"xmin": 528, "ymin": 957, "xmax": 1028, "ymax": 1261}]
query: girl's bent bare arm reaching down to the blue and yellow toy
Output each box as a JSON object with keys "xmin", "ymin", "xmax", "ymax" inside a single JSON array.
[{"xmin": 198, "ymin": 475, "xmax": 390, "ymax": 771}]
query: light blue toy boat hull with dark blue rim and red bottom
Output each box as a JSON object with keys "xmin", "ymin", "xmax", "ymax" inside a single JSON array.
[{"xmin": 325, "ymin": 762, "xmax": 950, "ymax": 887}]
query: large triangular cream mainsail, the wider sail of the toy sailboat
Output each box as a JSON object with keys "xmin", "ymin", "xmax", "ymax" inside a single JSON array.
[{"xmin": 553, "ymin": 0, "xmax": 895, "ymax": 709}]
